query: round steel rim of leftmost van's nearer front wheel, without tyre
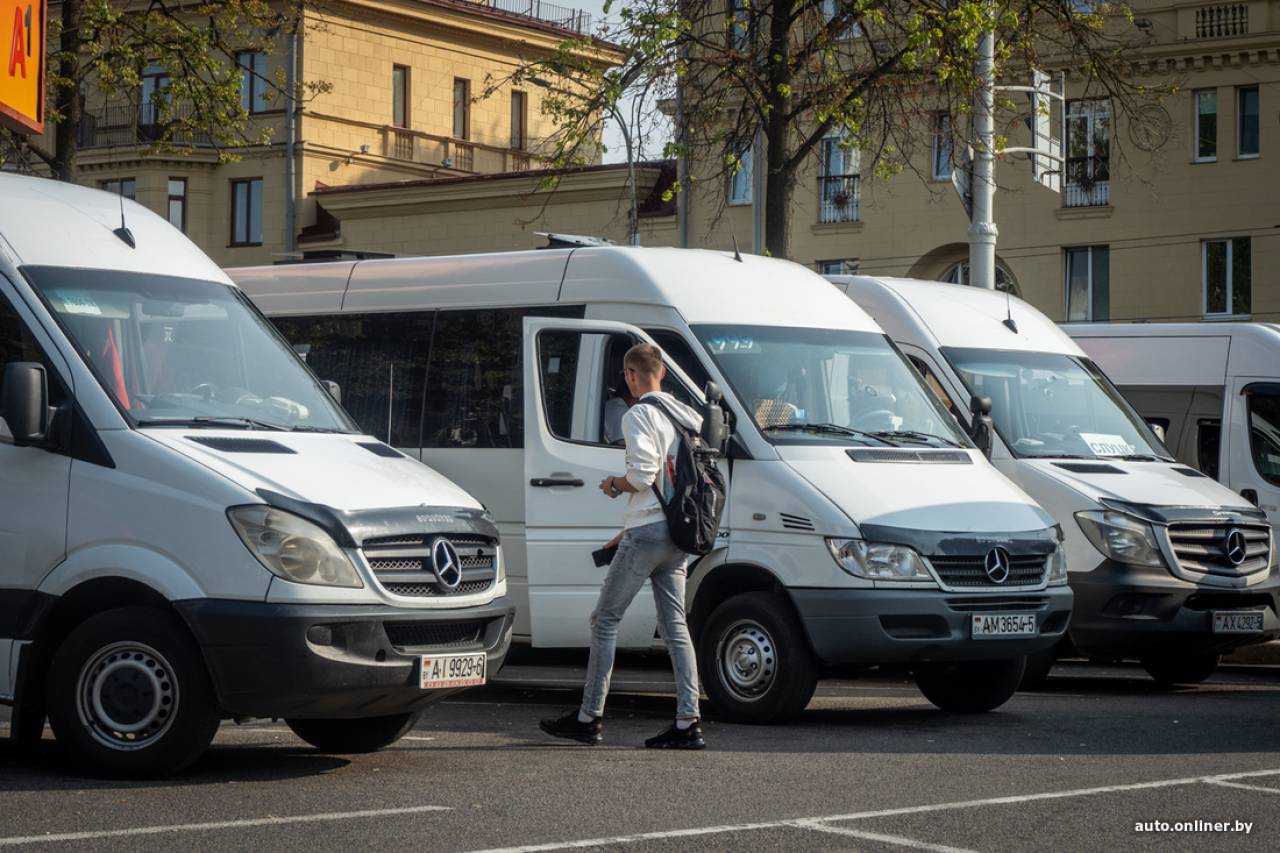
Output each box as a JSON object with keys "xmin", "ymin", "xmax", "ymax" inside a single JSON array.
[{"xmin": 76, "ymin": 640, "xmax": 178, "ymax": 752}]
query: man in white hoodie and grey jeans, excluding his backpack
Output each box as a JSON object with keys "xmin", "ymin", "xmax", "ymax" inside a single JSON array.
[{"xmin": 541, "ymin": 343, "xmax": 707, "ymax": 749}]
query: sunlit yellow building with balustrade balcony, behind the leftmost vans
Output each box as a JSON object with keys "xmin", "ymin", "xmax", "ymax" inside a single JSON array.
[{"xmin": 62, "ymin": 0, "xmax": 618, "ymax": 266}]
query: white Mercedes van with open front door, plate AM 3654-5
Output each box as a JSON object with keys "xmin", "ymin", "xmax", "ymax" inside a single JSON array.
[{"xmin": 229, "ymin": 247, "xmax": 1071, "ymax": 721}]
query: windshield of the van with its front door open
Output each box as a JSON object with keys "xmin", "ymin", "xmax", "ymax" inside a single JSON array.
[{"xmin": 692, "ymin": 325, "xmax": 970, "ymax": 447}]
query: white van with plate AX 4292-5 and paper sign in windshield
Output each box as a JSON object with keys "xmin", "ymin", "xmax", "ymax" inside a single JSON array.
[{"xmin": 833, "ymin": 277, "xmax": 1280, "ymax": 684}]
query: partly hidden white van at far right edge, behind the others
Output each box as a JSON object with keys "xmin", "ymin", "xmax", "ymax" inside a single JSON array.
[{"xmin": 1062, "ymin": 323, "xmax": 1280, "ymax": 528}]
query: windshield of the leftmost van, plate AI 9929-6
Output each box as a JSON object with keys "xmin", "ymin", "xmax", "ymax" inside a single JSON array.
[{"xmin": 23, "ymin": 266, "xmax": 355, "ymax": 433}]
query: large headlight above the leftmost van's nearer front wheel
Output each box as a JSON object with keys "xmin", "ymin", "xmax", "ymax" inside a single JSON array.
[{"xmin": 227, "ymin": 505, "xmax": 365, "ymax": 588}]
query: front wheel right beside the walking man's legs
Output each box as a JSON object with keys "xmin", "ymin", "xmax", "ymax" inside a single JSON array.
[{"xmin": 699, "ymin": 593, "xmax": 818, "ymax": 722}]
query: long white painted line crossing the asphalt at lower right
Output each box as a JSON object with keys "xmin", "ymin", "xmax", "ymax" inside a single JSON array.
[{"xmin": 460, "ymin": 768, "xmax": 1280, "ymax": 853}]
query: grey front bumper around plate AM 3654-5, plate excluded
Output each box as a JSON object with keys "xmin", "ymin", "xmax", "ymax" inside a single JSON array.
[{"xmin": 788, "ymin": 587, "xmax": 1071, "ymax": 665}]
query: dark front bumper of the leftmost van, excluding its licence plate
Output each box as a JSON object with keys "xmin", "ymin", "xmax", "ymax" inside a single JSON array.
[{"xmin": 175, "ymin": 598, "xmax": 515, "ymax": 719}]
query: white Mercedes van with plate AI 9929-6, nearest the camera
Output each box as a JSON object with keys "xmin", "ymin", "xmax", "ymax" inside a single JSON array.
[{"xmin": 0, "ymin": 174, "xmax": 512, "ymax": 776}]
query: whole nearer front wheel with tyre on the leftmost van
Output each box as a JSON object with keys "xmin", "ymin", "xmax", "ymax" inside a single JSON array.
[{"xmin": 45, "ymin": 607, "xmax": 221, "ymax": 779}]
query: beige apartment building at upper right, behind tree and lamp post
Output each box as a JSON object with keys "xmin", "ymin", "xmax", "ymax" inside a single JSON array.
[{"xmin": 689, "ymin": 0, "xmax": 1280, "ymax": 321}]
